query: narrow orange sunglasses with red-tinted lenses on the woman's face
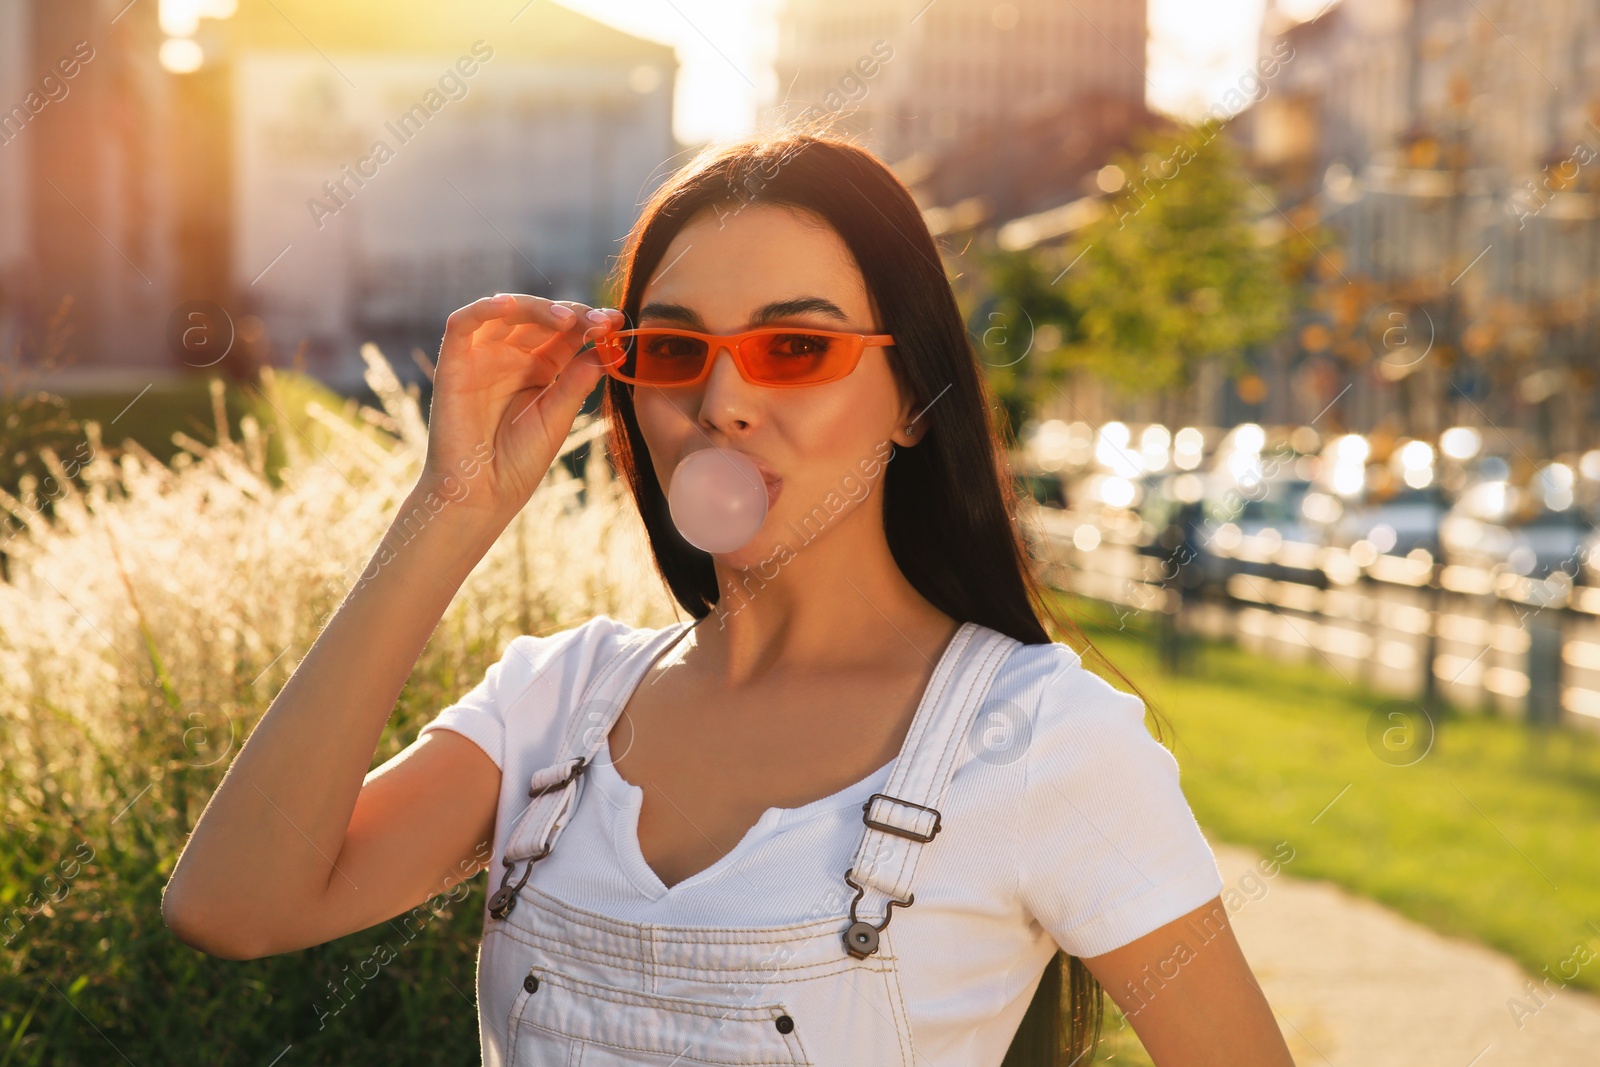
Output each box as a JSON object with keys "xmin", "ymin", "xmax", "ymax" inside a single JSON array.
[{"xmin": 594, "ymin": 326, "xmax": 894, "ymax": 389}]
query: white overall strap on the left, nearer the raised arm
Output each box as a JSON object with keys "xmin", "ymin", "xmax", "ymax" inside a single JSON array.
[{"xmin": 488, "ymin": 619, "xmax": 698, "ymax": 918}]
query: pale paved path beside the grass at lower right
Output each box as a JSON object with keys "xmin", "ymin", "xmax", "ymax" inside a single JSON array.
[{"xmin": 1213, "ymin": 843, "xmax": 1600, "ymax": 1067}]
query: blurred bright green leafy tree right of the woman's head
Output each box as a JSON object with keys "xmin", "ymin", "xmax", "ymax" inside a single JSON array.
[{"xmin": 989, "ymin": 123, "xmax": 1306, "ymax": 422}]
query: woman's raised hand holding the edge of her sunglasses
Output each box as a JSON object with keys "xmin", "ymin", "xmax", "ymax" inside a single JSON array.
[{"xmin": 421, "ymin": 293, "xmax": 622, "ymax": 522}]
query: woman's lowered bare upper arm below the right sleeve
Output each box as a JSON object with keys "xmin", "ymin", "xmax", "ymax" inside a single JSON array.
[{"xmin": 1083, "ymin": 897, "xmax": 1294, "ymax": 1067}]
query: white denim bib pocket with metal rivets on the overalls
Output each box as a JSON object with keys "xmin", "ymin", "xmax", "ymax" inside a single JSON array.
[{"xmin": 506, "ymin": 965, "xmax": 811, "ymax": 1067}]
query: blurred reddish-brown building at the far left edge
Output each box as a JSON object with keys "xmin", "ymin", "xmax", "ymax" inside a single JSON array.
[{"xmin": 0, "ymin": 0, "xmax": 179, "ymax": 385}]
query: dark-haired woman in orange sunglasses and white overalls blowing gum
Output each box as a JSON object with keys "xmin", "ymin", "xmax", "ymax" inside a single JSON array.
[{"xmin": 163, "ymin": 133, "xmax": 1291, "ymax": 1067}]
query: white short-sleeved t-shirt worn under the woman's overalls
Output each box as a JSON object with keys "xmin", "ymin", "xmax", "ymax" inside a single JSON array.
[{"xmin": 419, "ymin": 614, "xmax": 1222, "ymax": 1064}]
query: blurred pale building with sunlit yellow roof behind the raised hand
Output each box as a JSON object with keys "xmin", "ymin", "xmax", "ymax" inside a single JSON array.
[{"xmin": 226, "ymin": 0, "xmax": 677, "ymax": 378}]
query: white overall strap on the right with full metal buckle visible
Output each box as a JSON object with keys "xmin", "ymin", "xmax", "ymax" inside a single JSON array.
[{"xmin": 845, "ymin": 622, "xmax": 1022, "ymax": 960}]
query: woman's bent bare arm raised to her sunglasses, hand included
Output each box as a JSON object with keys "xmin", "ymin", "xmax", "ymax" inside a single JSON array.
[{"xmin": 162, "ymin": 296, "xmax": 619, "ymax": 958}]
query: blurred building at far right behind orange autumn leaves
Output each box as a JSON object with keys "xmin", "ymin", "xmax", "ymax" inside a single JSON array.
[{"xmin": 1250, "ymin": 0, "xmax": 1600, "ymax": 450}]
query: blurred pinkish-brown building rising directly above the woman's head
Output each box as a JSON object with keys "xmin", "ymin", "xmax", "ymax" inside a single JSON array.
[{"xmin": 770, "ymin": 0, "xmax": 1152, "ymax": 226}]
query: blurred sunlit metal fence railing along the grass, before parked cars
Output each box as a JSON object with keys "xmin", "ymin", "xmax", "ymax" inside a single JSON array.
[{"xmin": 1024, "ymin": 507, "xmax": 1600, "ymax": 729}]
